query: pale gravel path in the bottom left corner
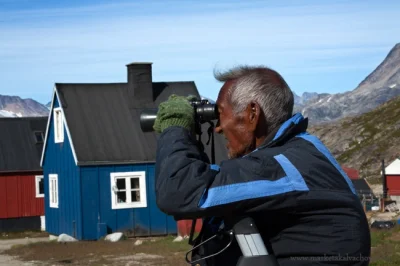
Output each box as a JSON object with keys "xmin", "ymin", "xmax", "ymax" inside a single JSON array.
[{"xmin": 0, "ymin": 237, "xmax": 49, "ymax": 266}]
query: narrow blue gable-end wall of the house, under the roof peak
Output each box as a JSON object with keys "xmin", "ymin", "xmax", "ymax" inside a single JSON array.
[{"xmin": 43, "ymin": 97, "xmax": 82, "ymax": 238}]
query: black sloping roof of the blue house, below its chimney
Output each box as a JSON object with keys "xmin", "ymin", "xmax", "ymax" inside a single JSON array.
[{"xmin": 56, "ymin": 82, "xmax": 227, "ymax": 165}]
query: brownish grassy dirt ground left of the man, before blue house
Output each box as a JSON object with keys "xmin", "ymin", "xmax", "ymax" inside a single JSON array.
[{"xmin": 2, "ymin": 236, "xmax": 190, "ymax": 266}]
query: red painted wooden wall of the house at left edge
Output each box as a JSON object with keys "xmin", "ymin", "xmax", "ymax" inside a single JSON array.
[{"xmin": 0, "ymin": 173, "xmax": 44, "ymax": 219}]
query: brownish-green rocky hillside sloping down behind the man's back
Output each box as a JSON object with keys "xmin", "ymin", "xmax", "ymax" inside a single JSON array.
[{"xmin": 309, "ymin": 96, "xmax": 400, "ymax": 178}]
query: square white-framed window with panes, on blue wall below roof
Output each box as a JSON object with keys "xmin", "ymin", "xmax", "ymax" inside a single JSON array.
[{"xmin": 111, "ymin": 172, "xmax": 147, "ymax": 209}]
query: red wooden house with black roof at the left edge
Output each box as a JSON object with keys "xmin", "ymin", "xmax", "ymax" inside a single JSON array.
[{"xmin": 0, "ymin": 117, "xmax": 47, "ymax": 232}]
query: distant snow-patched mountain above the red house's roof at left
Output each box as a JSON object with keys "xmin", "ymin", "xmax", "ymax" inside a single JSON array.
[{"xmin": 0, "ymin": 95, "xmax": 49, "ymax": 117}]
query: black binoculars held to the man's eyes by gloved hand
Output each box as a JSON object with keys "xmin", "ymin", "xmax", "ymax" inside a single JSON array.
[{"xmin": 140, "ymin": 100, "xmax": 218, "ymax": 132}]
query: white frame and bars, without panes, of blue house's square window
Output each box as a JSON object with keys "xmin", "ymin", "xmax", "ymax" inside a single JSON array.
[{"xmin": 110, "ymin": 171, "xmax": 147, "ymax": 209}]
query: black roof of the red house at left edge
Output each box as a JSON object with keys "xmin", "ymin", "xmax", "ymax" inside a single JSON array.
[{"xmin": 0, "ymin": 117, "xmax": 47, "ymax": 172}]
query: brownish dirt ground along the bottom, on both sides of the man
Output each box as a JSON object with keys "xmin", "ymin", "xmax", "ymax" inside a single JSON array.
[{"xmin": 0, "ymin": 225, "xmax": 400, "ymax": 266}]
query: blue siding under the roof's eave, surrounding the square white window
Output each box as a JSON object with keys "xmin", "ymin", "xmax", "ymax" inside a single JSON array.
[{"xmin": 81, "ymin": 164, "xmax": 177, "ymax": 239}]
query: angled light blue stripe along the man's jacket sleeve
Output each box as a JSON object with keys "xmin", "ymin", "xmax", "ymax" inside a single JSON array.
[{"xmin": 199, "ymin": 154, "xmax": 309, "ymax": 208}]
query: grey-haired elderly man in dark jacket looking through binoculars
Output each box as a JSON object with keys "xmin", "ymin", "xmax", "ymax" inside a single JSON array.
[{"xmin": 154, "ymin": 66, "xmax": 370, "ymax": 266}]
